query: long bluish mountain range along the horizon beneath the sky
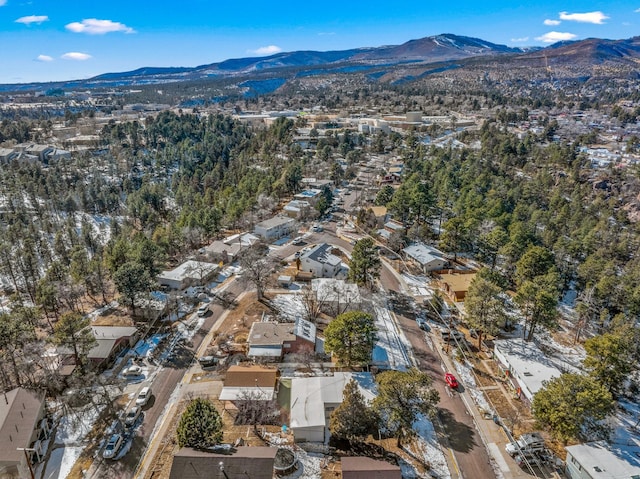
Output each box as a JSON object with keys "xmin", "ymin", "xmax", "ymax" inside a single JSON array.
[{"xmin": 0, "ymin": 33, "xmax": 640, "ymax": 91}]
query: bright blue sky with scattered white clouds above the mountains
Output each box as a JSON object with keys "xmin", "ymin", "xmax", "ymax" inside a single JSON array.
[{"xmin": 0, "ymin": 0, "xmax": 640, "ymax": 83}]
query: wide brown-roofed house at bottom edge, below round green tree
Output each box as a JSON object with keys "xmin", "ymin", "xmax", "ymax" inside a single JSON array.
[{"xmin": 169, "ymin": 446, "xmax": 278, "ymax": 479}]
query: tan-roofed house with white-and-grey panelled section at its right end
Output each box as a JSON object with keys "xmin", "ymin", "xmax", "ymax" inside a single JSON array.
[{"xmin": 247, "ymin": 318, "xmax": 316, "ymax": 360}]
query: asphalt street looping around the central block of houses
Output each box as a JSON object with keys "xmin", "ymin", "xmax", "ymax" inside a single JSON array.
[{"xmin": 91, "ymin": 222, "xmax": 495, "ymax": 479}]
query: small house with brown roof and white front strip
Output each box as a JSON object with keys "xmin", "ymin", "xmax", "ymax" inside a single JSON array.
[{"xmin": 219, "ymin": 364, "xmax": 278, "ymax": 408}]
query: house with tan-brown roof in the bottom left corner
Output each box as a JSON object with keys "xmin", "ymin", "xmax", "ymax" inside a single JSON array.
[{"xmin": 0, "ymin": 388, "xmax": 50, "ymax": 479}]
